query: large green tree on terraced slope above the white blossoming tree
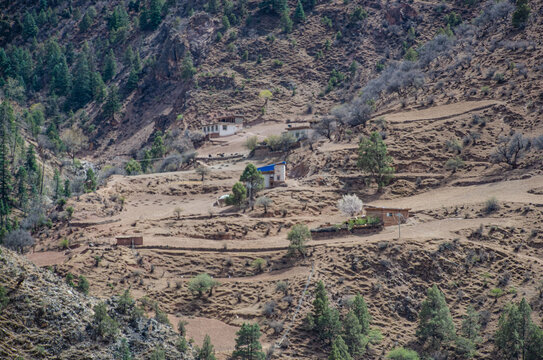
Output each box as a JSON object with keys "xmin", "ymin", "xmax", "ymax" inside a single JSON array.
[{"xmin": 358, "ymin": 131, "xmax": 394, "ymax": 190}]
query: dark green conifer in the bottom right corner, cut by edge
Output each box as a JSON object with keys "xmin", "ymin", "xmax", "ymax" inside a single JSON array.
[{"xmin": 494, "ymin": 298, "xmax": 543, "ymax": 360}]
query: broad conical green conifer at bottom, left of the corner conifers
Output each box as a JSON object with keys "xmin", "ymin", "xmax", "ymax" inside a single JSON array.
[{"xmin": 417, "ymin": 284, "xmax": 455, "ymax": 349}]
